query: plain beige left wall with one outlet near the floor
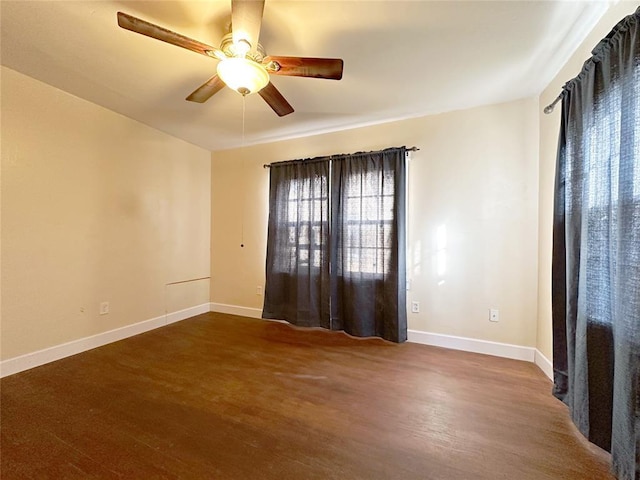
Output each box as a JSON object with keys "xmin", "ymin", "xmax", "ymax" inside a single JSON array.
[{"xmin": 1, "ymin": 67, "xmax": 211, "ymax": 359}]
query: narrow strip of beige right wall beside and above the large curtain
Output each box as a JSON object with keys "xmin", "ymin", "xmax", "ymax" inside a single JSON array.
[{"xmin": 537, "ymin": 1, "xmax": 638, "ymax": 359}]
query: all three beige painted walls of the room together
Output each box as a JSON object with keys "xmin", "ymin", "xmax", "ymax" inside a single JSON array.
[{"xmin": 0, "ymin": 1, "xmax": 637, "ymax": 366}]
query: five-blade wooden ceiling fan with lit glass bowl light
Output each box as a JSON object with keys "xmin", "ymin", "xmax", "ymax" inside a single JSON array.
[{"xmin": 118, "ymin": 0, "xmax": 343, "ymax": 117}]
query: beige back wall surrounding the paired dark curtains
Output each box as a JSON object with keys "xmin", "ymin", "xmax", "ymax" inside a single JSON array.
[{"xmin": 211, "ymin": 99, "xmax": 538, "ymax": 346}]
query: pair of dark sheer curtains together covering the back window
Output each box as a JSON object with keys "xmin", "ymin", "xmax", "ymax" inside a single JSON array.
[{"xmin": 262, "ymin": 147, "xmax": 407, "ymax": 342}]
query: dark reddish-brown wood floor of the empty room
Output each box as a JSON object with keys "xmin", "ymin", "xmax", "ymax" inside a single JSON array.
[{"xmin": 0, "ymin": 313, "xmax": 613, "ymax": 480}]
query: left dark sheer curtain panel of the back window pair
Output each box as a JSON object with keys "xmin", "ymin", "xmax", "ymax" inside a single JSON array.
[{"xmin": 262, "ymin": 160, "xmax": 330, "ymax": 328}]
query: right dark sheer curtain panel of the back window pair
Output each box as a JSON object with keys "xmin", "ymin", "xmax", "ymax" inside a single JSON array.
[{"xmin": 331, "ymin": 148, "xmax": 407, "ymax": 342}]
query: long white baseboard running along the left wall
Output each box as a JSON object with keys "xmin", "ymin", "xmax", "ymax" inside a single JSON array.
[{"xmin": 0, "ymin": 303, "xmax": 209, "ymax": 378}]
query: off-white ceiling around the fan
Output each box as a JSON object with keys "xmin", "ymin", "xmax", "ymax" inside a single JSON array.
[{"xmin": 0, "ymin": 0, "xmax": 610, "ymax": 150}]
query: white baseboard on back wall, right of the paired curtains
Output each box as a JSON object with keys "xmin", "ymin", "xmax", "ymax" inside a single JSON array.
[{"xmin": 407, "ymin": 330, "xmax": 536, "ymax": 362}]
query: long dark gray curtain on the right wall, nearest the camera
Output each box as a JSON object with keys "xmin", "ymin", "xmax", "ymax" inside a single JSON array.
[{"xmin": 552, "ymin": 9, "xmax": 640, "ymax": 480}]
